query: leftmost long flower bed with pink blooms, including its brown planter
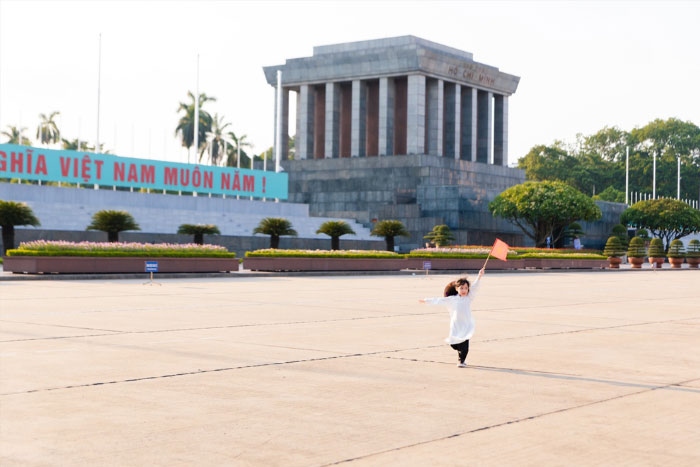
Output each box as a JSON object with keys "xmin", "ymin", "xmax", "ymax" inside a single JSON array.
[{"xmin": 3, "ymin": 240, "xmax": 238, "ymax": 274}]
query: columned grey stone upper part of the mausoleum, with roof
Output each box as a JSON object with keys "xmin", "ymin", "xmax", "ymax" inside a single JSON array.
[{"xmin": 264, "ymin": 36, "xmax": 520, "ymax": 166}]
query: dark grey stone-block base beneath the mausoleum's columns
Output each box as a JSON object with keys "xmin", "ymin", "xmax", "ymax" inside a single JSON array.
[{"xmin": 284, "ymin": 155, "xmax": 527, "ymax": 250}]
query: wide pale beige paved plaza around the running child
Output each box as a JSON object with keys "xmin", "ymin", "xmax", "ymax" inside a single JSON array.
[{"xmin": 0, "ymin": 270, "xmax": 700, "ymax": 466}]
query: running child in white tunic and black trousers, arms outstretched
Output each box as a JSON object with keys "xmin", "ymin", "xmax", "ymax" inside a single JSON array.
[{"xmin": 418, "ymin": 268, "xmax": 484, "ymax": 368}]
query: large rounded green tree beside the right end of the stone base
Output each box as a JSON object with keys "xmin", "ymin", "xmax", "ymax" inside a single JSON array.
[{"xmin": 489, "ymin": 182, "xmax": 602, "ymax": 247}]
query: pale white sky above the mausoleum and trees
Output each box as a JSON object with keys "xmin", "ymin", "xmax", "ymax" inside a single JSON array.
[{"xmin": 0, "ymin": 0, "xmax": 700, "ymax": 165}]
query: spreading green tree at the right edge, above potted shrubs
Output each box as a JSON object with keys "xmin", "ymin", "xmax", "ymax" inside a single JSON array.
[{"xmin": 620, "ymin": 199, "xmax": 700, "ymax": 249}]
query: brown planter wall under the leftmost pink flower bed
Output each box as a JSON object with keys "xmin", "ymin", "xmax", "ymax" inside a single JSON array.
[{"xmin": 3, "ymin": 256, "xmax": 238, "ymax": 274}]
